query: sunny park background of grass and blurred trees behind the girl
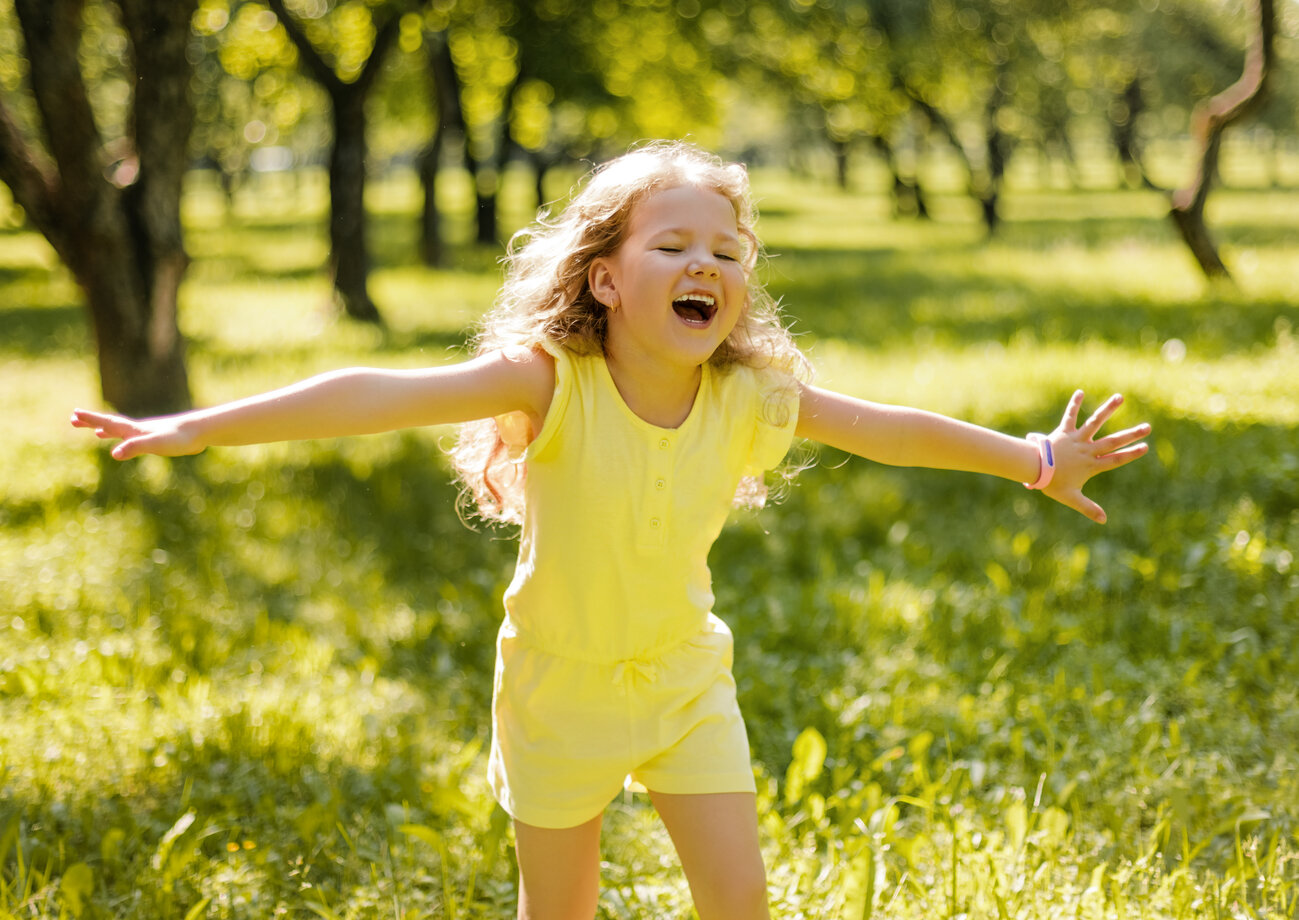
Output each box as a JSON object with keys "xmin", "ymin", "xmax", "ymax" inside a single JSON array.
[{"xmin": 0, "ymin": 0, "xmax": 1299, "ymax": 920}]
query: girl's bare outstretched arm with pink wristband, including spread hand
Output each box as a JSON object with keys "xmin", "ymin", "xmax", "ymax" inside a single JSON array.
[{"xmin": 798, "ymin": 386, "xmax": 1150, "ymax": 524}]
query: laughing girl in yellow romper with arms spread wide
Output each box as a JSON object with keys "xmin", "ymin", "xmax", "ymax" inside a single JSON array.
[{"xmin": 73, "ymin": 143, "xmax": 1150, "ymax": 920}]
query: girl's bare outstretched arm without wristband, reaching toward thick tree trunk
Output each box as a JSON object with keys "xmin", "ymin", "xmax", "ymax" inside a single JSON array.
[{"xmin": 71, "ymin": 352, "xmax": 555, "ymax": 460}]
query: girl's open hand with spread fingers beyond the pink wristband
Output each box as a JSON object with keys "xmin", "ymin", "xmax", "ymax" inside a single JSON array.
[{"xmin": 1042, "ymin": 390, "xmax": 1150, "ymax": 524}]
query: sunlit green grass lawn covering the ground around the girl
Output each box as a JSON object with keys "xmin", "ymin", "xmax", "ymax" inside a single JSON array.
[{"xmin": 0, "ymin": 161, "xmax": 1299, "ymax": 920}]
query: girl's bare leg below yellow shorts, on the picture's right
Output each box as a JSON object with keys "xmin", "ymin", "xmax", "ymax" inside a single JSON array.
[{"xmin": 650, "ymin": 791, "xmax": 770, "ymax": 920}]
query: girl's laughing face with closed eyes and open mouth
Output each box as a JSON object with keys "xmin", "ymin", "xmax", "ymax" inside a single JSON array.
[{"xmin": 588, "ymin": 186, "xmax": 748, "ymax": 369}]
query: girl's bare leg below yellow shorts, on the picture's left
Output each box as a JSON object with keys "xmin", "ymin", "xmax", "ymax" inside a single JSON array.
[{"xmin": 514, "ymin": 815, "xmax": 603, "ymax": 920}]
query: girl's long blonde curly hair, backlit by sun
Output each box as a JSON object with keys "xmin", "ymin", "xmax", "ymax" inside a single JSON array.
[{"xmin": 451, "ymin": 142, "xmax": 811, "ymax": 524}]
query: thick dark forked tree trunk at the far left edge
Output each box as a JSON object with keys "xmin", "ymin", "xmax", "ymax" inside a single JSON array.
[{"xmin": 0, "ymin": 0, "xmax": 196, "ymax": 415}]
